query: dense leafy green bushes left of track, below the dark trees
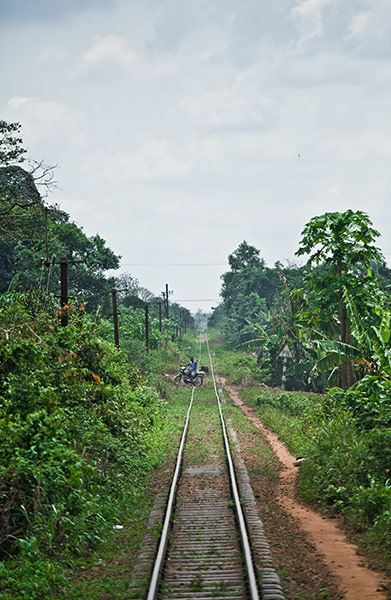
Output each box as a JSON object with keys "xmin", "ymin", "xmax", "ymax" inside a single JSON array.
[{"xmin": 0, "ymin": 292, "xmax": 168, "ymax": 598}]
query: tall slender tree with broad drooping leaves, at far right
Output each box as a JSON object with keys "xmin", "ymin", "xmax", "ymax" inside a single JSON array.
[{"xmin": 296, "ymin": 209, "xmax": 382, "ymax": 389}]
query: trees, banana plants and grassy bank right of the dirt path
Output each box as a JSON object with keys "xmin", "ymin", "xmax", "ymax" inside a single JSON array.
[{"xmin": 210, "ymin": 210, "xmax": 391, "ymax": 557}]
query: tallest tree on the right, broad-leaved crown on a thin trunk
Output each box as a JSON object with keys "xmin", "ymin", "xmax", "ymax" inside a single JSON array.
[{"xmin": 296, "ymin": 210, "xmax": 382, "ymax": 389}]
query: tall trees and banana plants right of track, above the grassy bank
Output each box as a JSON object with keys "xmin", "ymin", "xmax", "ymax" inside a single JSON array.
[{"xmin": 209, "ymin": 210, "xmax": 391, "ymax": 392}]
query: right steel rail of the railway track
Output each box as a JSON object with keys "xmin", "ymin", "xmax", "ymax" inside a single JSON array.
[{"xmin": 205, "ymin": 332, "xmax": 259, "ymax": 600}]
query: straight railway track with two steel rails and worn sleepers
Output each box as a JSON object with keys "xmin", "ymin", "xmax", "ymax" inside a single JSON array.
[{"xmin": 132, "ymin": 337, "xmax": 284, "ymax": 600}]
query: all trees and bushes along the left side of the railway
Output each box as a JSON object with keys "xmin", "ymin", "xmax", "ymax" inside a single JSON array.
[{"xmin": 0, "ymin": 121, "xmax": 198, "ymax": 600}]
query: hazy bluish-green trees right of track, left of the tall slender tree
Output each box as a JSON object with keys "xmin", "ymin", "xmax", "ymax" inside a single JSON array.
[{"xmin": 214, "ymin": 242, "xmax": 309, "ymax": 387}]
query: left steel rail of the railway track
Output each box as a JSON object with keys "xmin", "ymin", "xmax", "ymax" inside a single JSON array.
[{"xmin": 147, "ymin": 387, "xmax": 195, "ymax": 600}]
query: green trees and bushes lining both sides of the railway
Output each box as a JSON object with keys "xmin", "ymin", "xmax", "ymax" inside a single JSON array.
[{"xmin": 0, "ymin": 121, "xmax": 391, "ymax": 600}]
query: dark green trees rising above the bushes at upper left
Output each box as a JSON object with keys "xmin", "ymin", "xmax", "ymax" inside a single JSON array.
[{"xmin": 0, "ymin": 166, "xmax": 119, "ymax": 310}]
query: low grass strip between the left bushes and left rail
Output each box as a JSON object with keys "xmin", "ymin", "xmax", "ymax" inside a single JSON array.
[{"xmin": 61, "ymin": 387, "xmax": 190, "ymax": 600}]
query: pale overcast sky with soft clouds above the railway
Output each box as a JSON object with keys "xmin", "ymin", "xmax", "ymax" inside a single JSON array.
[{"xmin": 0, "ymin": 0, "xmax": 391, "ymax": 312}]
